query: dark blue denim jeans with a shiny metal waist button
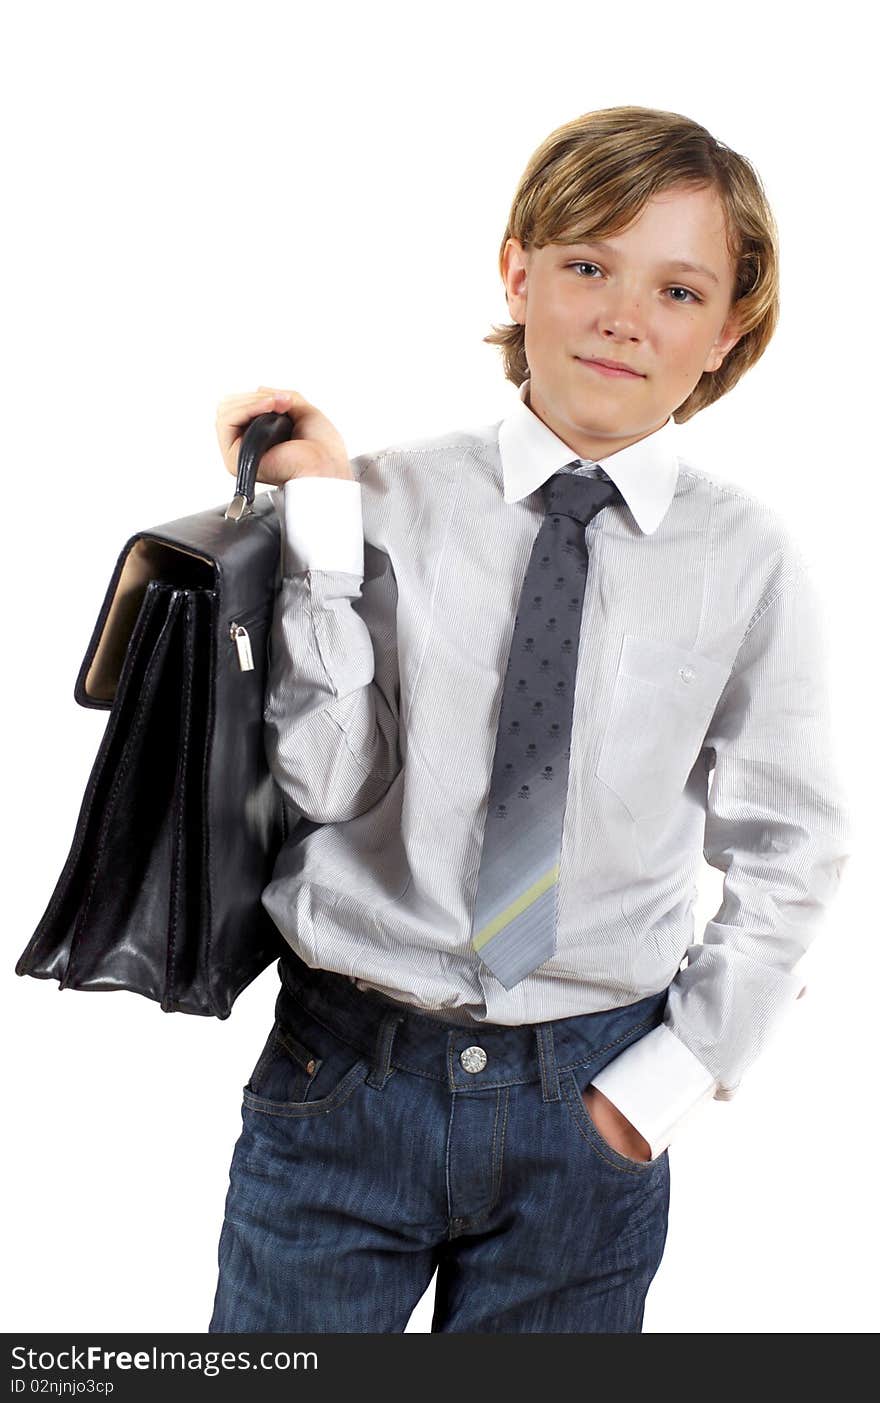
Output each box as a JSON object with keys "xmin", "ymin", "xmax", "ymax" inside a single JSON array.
[{"xmin": 208, "ymin": 951, "xmax": 669, "ymax": 1334}]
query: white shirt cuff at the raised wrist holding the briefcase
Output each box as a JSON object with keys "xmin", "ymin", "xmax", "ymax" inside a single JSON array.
[{"xmin": 274, "ymin": 477, "xmax": 364, "ymax": 575}]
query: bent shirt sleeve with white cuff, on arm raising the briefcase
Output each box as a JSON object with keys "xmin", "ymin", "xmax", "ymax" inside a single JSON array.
[{"xmin": 262, "ymin": 455, "xmax": 401, "ymax": 824}]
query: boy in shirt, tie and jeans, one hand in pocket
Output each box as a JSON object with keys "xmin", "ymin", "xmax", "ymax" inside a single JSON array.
[{"xmin": 209, "ymin": 107, "xmax": 846, "ymax": 1333}]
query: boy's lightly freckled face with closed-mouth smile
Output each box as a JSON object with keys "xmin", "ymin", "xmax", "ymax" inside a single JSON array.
[{"xmin": 502, "ymin": 189, "xmax": 740, "ymax": 459}]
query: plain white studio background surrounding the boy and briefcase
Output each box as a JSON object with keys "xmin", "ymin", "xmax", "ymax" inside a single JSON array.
[{"xmin": 0, "ymin": 0, "xmax": 879, "ymax": 1333}]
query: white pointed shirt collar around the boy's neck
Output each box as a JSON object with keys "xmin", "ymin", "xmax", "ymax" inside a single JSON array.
[{"xmin": 498, "ymin": 379, "xmax": 679, "ymax": 535}]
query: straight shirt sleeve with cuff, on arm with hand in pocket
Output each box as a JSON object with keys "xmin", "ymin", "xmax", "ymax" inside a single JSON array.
[{"xmin": 594, "ymin": 561, "xmax": 851, "ymax": 1159}]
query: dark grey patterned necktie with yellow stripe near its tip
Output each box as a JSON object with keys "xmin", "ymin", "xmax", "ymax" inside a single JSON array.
[{"xmin": 472, "ymin": 459, "xmax": 622, "ymax": 989}]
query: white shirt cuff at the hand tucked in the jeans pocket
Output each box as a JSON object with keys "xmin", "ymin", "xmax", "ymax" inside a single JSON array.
[{"xmin": 592, "ymin": 1023, "xmax": 716, "ymax": 1159}]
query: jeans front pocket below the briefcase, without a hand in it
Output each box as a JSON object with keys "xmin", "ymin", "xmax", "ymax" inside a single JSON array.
[{"xmin": 241, "ymin": 995, "xmax": 369, "ymax": 1115}]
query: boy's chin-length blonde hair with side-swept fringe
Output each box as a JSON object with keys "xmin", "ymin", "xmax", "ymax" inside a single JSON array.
[{"xmin": 483, "ymin": 107, "xmax": 779, "ymax": 424}]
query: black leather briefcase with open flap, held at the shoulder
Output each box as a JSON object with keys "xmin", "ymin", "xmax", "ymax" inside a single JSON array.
[{"xmin": 15, "ymin": 412, "xmax": 317, "ymax": 1019}]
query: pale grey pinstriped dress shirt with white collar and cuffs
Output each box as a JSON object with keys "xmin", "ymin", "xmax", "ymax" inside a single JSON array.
[{"xmin": 262, "ymin": 380, "xmax": 849, "ymax": 1157}]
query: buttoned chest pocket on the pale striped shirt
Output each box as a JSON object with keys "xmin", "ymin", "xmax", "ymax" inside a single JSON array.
[{"xmin": 595, "ymin": 634, "xmax": 730, "ymax": 818}]
